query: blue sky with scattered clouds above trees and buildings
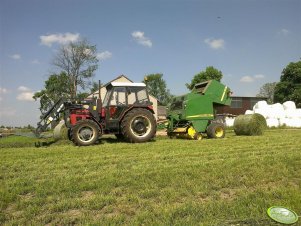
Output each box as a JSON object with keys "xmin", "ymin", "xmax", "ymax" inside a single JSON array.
[{"xmin": 0, "ymin": 0, "xmax": 301, "ymax": 126}]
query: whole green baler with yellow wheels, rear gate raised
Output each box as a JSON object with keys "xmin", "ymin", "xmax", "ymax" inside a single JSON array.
[{"xmin": 167, "ymin": 80, "xmax": 231, "ymax": 140}]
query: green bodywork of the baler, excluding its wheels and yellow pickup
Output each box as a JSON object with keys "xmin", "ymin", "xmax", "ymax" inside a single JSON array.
[{"xmin": 167, "ymin": 80, "xmax": 231, "ymax": 133}]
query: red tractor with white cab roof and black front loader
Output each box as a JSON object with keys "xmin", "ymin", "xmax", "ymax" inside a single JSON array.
[{"xmin": 36, "ymin": 82, "xmax": 156, "ymax": 146}]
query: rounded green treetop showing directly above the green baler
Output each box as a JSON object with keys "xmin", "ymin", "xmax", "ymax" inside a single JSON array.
[{"xmin": 186, "ymin": 66, "xmax": 223, "ymax": 90}]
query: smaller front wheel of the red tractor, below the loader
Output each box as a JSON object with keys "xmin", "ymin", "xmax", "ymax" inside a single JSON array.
[{"xmin": 72, "ymin": 120, "xmax": 100, "ymax": 146}]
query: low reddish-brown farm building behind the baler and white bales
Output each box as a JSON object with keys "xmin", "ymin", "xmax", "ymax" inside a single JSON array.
[{"xmin": 216, "ymin": 96, "xmax": 267, "ymax": 115}]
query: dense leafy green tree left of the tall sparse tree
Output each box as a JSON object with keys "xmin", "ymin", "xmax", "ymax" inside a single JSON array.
[{"xmin": 33, "ymin": 72, "xmax": 71, "ymax": 113}]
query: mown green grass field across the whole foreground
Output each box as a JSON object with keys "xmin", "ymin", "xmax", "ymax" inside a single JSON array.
[{"xmin": 0, "ymin": 130, "xmax": 301, "ymax": 226}]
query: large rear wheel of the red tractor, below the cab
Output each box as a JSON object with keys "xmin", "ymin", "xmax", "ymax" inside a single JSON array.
[{"xmin": 121, "ymin": 108, "xmax": 157, "ymax": 143}]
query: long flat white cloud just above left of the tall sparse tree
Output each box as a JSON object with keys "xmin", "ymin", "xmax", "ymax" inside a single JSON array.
[{"xmin": 40, "ymin": 32, "xmax": 80, "ymax": 47}]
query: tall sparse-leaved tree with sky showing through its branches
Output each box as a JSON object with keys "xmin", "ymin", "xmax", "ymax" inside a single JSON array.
[{"xmin": 53, "ymin": 40, "xmax": 98, "ymax": 98}]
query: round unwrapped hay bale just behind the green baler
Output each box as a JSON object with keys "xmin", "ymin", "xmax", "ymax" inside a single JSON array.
[{"xmin": 233, "ymin": 113, "xmax": 267, "ymax": 136}]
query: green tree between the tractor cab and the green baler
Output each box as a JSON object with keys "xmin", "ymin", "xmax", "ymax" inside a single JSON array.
[{"xmin": 144, "ymin": 74, "xmax": 172, "ymax": 105}]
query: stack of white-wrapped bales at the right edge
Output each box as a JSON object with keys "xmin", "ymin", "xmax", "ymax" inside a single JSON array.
[{"xmin": 245, "ymin": 101, "xmax": 301, "ymax": 128}]
